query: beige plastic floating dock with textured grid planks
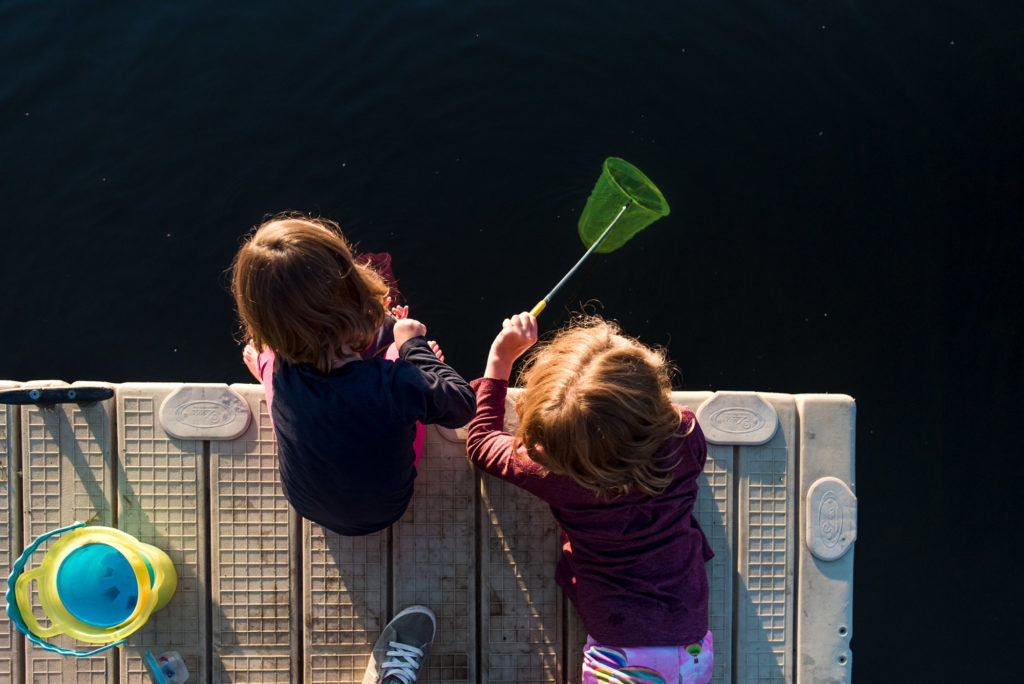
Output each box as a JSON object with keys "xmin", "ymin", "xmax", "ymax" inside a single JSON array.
[{"xmin": 0, "ymin": 381, "xmax": 856, "ymax": 684}]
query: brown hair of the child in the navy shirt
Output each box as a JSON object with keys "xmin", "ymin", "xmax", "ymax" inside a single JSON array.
[{"xmin": 230, "ymin": 213, "xmax": 388, "ymax": 373}]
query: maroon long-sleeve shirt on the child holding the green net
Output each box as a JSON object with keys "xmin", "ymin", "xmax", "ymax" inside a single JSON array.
[{"xmin": 466, "ymin": 378, "xmax": 714, "ymax": 647}]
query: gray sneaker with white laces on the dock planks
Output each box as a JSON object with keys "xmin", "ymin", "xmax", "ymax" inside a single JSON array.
[{"xmin": 362, "ymin": 605, "xmax": 437, "ymax": 684}]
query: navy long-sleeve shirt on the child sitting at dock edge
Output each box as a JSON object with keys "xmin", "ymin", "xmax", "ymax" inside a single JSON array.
[{"xmin": 264, "ymin": 336, "xmax": 476, "ymax": 536}]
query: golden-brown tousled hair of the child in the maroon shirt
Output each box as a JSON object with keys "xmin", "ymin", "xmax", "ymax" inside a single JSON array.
[{"xmin": 515, "ymin": 316, "xmax": 692, "ymax": 497}]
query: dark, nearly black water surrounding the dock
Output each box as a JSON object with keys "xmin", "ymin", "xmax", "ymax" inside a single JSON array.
[{"xmin": 0, "ymin": 0, "xmax": 1024, "ymax": 682}]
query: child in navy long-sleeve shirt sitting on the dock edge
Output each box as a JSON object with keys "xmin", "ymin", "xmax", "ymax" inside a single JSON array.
[{"xmin": 231, "ymin": 214, "xmax": 475, "ymax": 536}]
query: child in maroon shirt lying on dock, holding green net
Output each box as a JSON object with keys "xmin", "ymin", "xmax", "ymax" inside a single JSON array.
[{"xmin": 466, "ymin": 312, "xmax": 714, "ymax": 683}]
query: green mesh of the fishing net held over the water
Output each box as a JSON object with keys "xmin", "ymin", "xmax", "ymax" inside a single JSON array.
[{"xmin": 579, "ymin": 157, "xmax": 669, "ymax": 253}]
